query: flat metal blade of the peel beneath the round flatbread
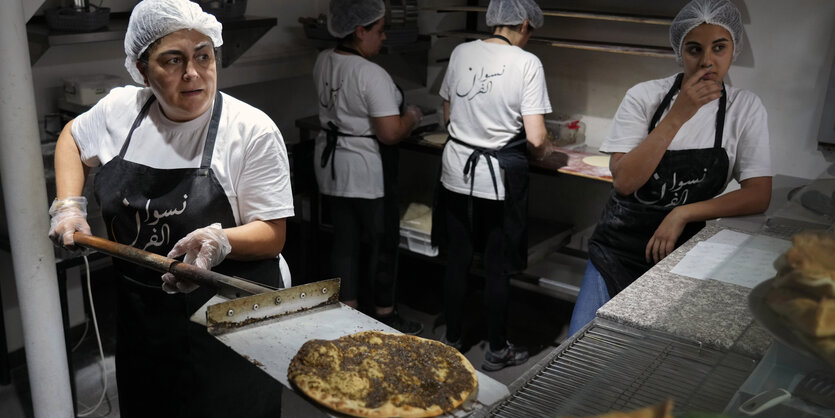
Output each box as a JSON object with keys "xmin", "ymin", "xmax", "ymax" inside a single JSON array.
[{"xmin": 192, "ymin": 278, "xmax": 510, "ymax": 416}]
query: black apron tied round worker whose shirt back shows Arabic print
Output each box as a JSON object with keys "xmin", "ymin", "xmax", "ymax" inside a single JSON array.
[{"xmin": 432, "ymin": 129, "xmax": 529, "ymax": 275}]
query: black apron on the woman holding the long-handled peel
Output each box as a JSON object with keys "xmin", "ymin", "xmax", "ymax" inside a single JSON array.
[{"xmin": 94, "ymin": 92, "xmax": 281, "ymax": 417}]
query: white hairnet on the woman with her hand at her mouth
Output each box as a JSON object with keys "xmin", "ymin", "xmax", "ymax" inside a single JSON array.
[{"xmin": 670, "ymin": 0, "xmax": 742, "ymax": 64}]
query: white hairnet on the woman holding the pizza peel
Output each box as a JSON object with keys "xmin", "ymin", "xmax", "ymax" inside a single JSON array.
[{"xmin": 125, "ymin": 0, "xmax": 223, "ymax": 84}]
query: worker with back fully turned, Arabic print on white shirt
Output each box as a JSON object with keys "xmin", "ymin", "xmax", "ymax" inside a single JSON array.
[{"xmin": 432, "ymin": 0, "xmax": 551, "ymax": 371}]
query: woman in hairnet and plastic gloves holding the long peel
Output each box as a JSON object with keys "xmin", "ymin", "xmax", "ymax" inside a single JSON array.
[{"xmin": 49, "ymin": 0, "xmax": 293, "ymax": 417}]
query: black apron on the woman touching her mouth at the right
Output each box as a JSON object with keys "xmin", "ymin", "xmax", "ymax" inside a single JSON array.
[{"xmin": 589, "ymin": 74, "xmax": 729, "ymax": 296}]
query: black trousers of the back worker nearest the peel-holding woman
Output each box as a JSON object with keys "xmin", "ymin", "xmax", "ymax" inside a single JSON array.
[{"xmin": 326, "ymin": 196, "xmax": 396, "ymax": 307}]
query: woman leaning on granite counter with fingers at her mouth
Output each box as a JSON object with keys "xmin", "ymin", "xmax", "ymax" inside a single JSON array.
[{"xmin": 569, "ymin": 0, "xmax": 771, "ymax": 335}]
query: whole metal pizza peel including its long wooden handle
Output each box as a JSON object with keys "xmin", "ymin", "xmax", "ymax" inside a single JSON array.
[{"xmin": 73, "ymin": 232, "xmax": 510, "ymax": 416}]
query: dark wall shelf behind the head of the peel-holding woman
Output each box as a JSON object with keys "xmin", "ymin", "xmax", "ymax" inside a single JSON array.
[{"xmin": 26, "ymin": 13, "xmax": 277, "ymax": 68}]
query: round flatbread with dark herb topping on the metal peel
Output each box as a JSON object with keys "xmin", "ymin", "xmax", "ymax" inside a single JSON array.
[{"xmin": 287, "ymin": 331, "xmax": 478, "ymax": 417}]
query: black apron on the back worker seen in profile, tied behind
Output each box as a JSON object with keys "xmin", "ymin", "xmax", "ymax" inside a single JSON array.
[{"xmin": 319, "ymin": 45, "xmax": 406, "ymax": 290}]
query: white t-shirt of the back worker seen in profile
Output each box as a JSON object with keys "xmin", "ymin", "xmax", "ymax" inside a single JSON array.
[{"xmin": 313, "ymin": 49, "xmax": 403, "ymax": 199}]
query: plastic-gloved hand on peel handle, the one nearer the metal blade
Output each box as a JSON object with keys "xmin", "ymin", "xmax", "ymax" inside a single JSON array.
[{"xmin": 162, "ymin": 223, "xmax": 232, "ymax": 294}]
